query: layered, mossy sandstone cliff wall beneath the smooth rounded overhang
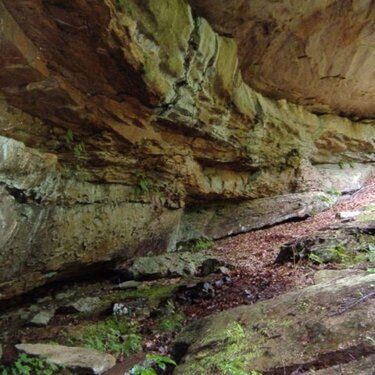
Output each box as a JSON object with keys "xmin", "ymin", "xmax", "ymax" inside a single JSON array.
[{"xmin": 0, "ymin": 0, "xmax": 375, "ymax": 298}]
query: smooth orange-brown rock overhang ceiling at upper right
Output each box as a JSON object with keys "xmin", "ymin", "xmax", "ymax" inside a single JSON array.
[{"xmin": 190, "ymin": 0, "xmax": 375, "ymax": 117}]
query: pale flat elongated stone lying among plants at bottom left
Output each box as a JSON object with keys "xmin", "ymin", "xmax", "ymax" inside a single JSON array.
[{"xmin": 16, "ymin": 344, "xmax": 116, "ymax": 374}]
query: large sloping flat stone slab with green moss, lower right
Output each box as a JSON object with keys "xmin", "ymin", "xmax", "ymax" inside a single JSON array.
[{"xmin": 174, "ymin": 274, "xmax": 375, "ymax": 375}]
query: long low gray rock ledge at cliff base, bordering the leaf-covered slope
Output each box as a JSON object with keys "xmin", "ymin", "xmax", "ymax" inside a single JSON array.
[{"xmin": 179, "ymin": 192, "xmax": 337, "ymax": 242}]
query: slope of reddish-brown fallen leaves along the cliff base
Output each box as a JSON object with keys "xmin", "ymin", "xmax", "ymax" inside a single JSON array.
[{"xmin": 178, "ymin": 178, "xmax": 375, "ymax": 319}]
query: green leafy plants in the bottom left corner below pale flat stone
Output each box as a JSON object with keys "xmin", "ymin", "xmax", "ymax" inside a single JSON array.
[{"xmin": 0, "ymin": 353, "xmax": 63, "ymax": 375}]
